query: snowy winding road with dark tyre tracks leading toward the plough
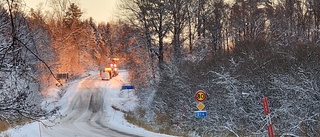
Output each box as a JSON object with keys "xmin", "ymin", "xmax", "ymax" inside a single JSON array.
[{"xmin": 41, "ymin": 72, "xmax": 144, "ymax": 137}]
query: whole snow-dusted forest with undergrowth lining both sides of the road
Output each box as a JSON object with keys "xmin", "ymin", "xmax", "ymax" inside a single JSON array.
[{"xmin": 0, "ymin": 0, "xmax": 320, "ymax": 136}]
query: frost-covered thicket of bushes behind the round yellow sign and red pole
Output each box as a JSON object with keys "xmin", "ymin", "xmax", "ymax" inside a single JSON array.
[{"xmin": 150, "ymin": 41, "xmax": 320, "ymax": 136}]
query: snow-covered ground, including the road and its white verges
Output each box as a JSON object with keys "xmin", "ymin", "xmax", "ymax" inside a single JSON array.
[{"xmin": 0, "ymin": 71, "xmax": 176, "ymax": 137}]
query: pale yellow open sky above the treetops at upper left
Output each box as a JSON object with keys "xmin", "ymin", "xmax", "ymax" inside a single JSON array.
[{"xmin": 23, "ymin": 0, "xmax": 119, "ymax": 22}]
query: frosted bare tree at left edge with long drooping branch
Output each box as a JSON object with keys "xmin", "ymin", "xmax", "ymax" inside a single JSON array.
[{"xmin": 0, "ymin": 0, "xmax": 58, "ymax": 122}]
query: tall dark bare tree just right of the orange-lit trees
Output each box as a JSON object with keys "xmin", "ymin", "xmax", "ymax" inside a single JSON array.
[{"xmin": 123, "ymin": 0, "xmax": 170, "ymax": 72}]
